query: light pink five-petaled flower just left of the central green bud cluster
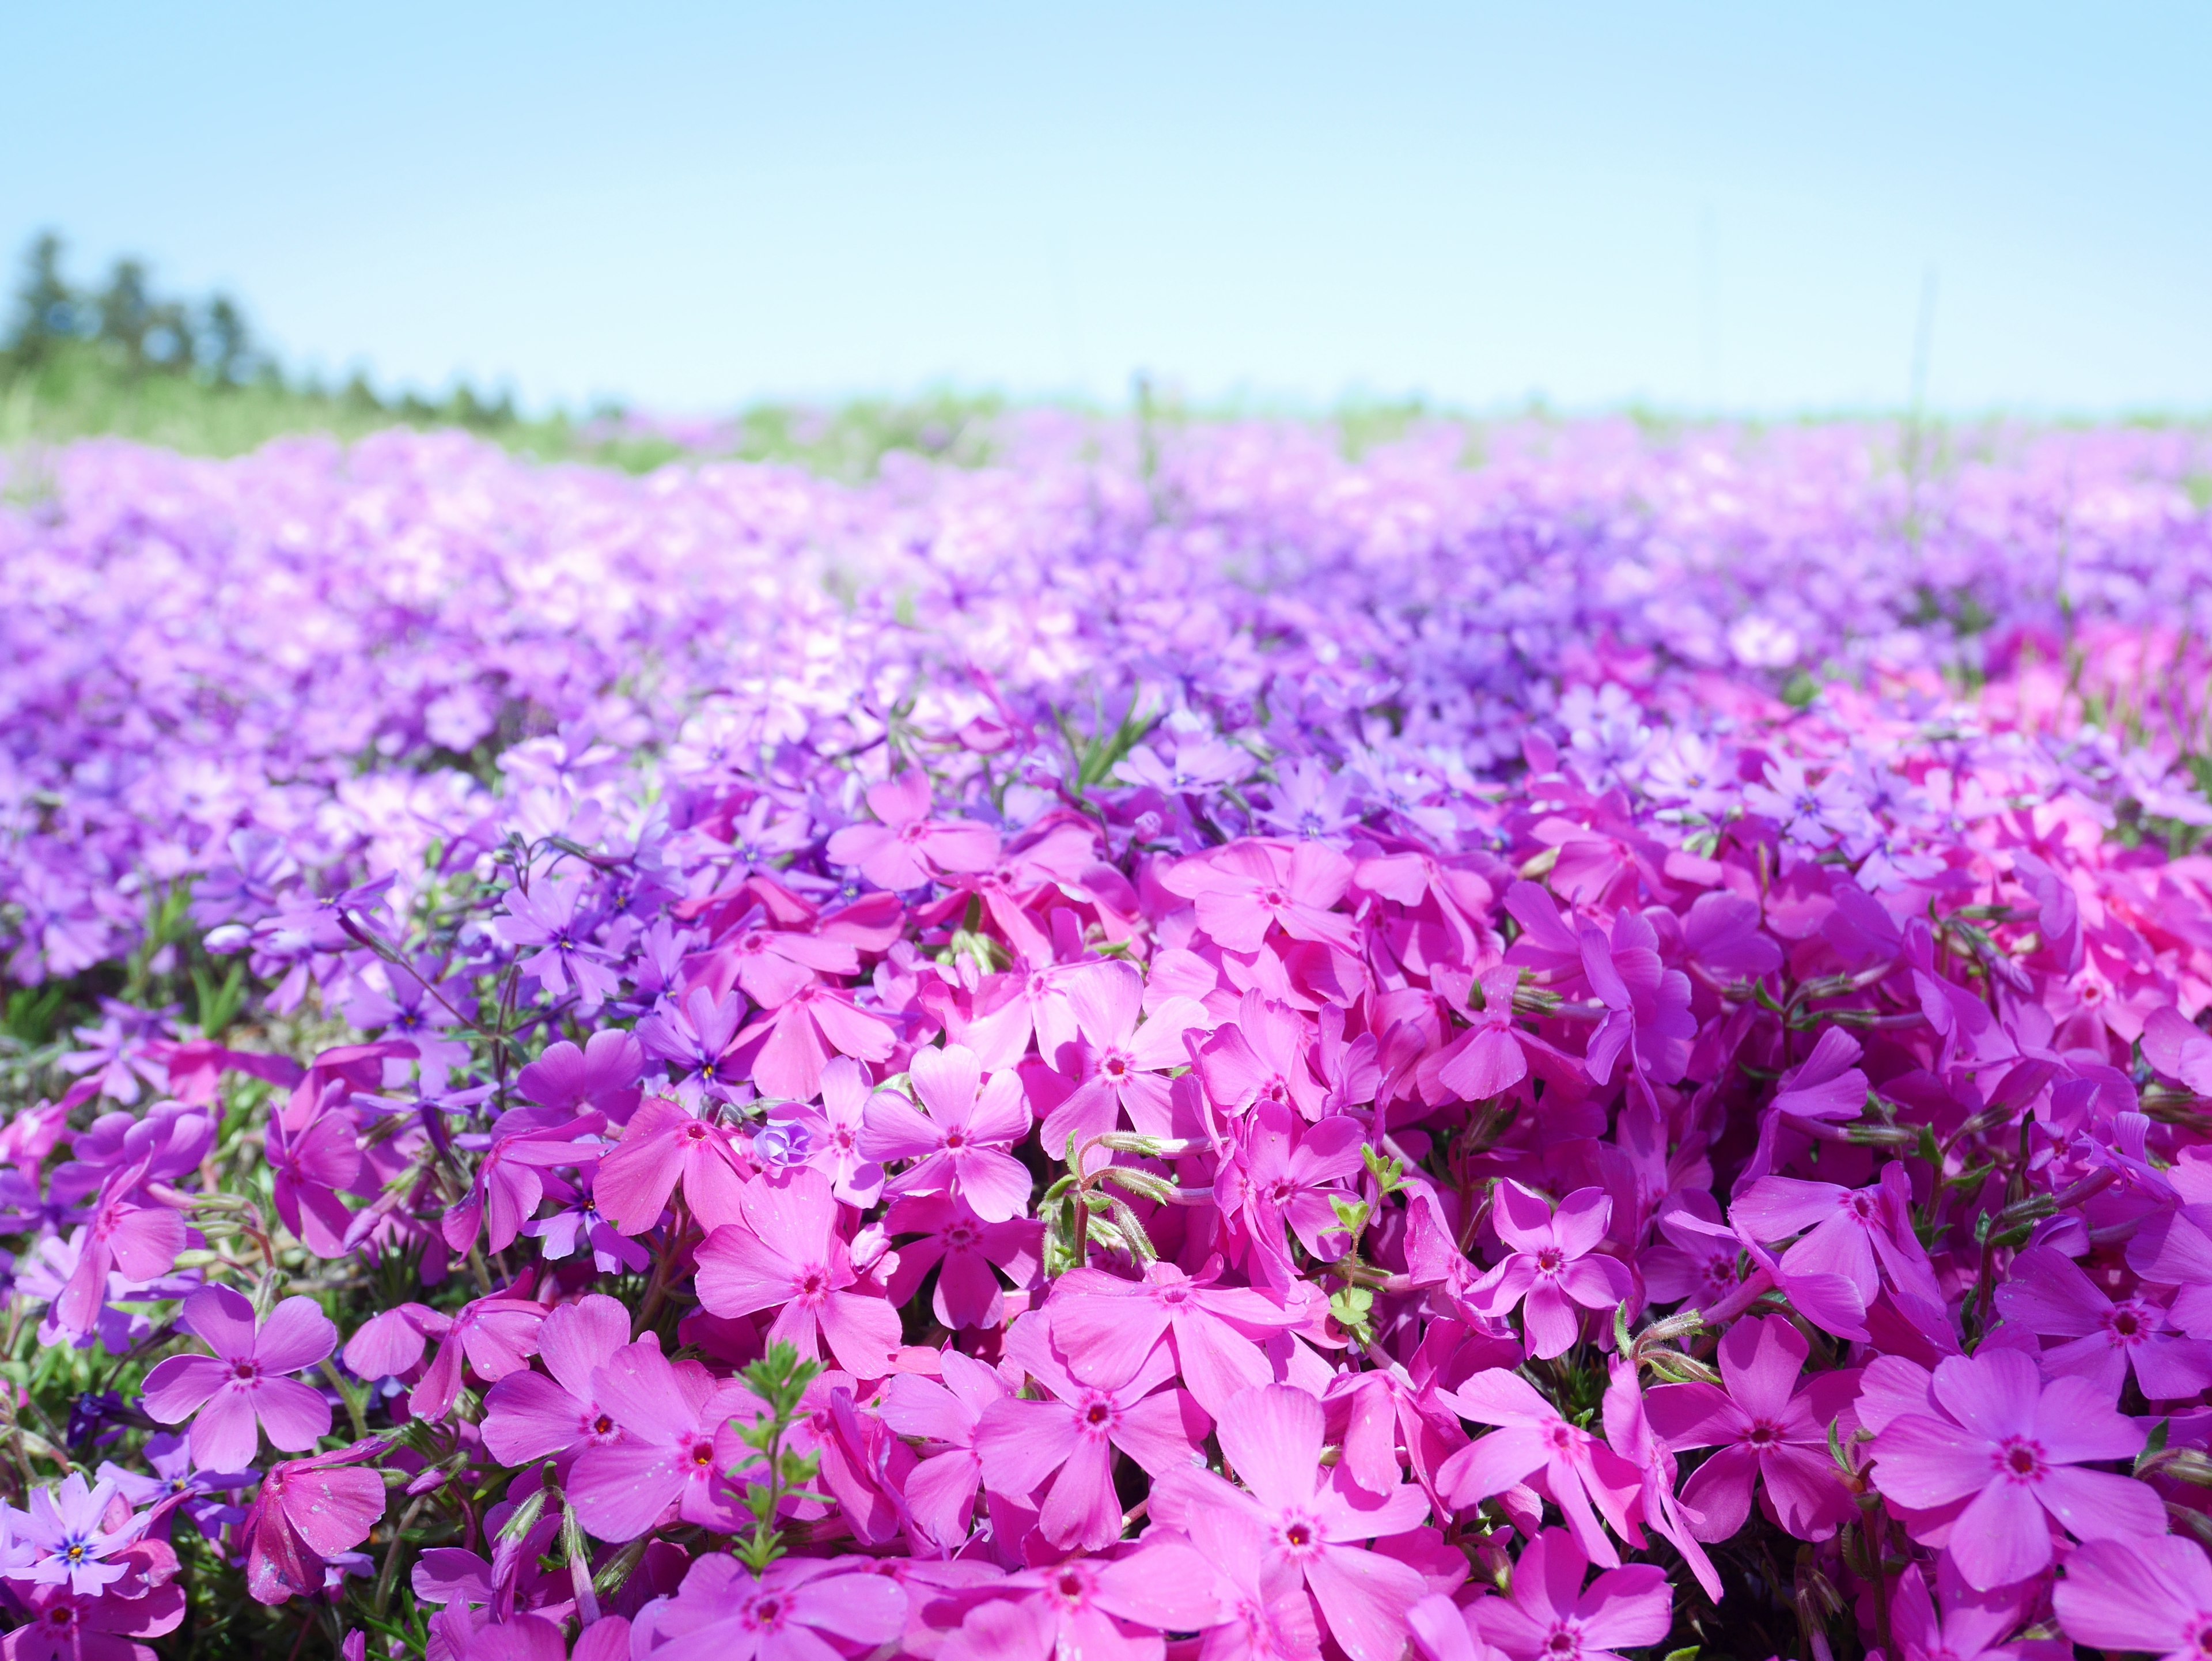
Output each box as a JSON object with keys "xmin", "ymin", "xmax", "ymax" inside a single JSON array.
[{"xmin": 861, "ymin": 1044, "xmax": 1031, "ymax": 1223}]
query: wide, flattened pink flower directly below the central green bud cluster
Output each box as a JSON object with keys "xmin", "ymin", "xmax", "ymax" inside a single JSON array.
[{"xmin": 1048, "ymin": 1263, "xmax": 1307, "ymax": 1416}]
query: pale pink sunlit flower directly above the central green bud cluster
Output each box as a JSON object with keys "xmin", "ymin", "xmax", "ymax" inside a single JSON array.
[{"xmin": 1042, "ymin": 962, "xmax": 1206, "ymax": 1159}]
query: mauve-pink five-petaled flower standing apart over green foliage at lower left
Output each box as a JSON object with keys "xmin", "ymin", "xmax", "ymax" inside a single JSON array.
[{"xmin": 146, "ymin": 1287, "xmax": 339, "ymax": 1471}]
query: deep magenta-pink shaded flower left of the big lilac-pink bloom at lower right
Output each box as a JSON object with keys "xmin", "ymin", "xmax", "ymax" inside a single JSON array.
[{"xmin": 1643, "ymin": 1316, "xmax": 1858, "ymax": 1539}]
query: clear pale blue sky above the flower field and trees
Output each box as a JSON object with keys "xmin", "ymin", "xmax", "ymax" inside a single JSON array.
[{"xmin": 0, "ymin": 0, "xmax": 2212, "ymax": 414}]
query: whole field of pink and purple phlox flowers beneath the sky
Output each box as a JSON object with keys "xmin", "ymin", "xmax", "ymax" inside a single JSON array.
[{"xmin": 0, "ymin": 414, "xmax": 2212, "ymax": 1661}]
